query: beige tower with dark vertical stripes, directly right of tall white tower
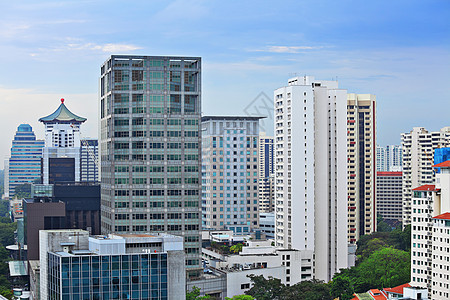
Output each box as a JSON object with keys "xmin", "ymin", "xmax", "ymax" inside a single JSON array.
[{"xmin": 347, "ymin": 94, "xmax": 377, "ymax": 244}]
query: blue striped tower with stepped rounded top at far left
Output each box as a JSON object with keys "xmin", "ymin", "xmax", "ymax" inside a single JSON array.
[{"xmin": 4, "ymin": 124, "xmax": 44, "ymax": 199}]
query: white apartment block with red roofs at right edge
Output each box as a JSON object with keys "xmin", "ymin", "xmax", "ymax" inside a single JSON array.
[{"xmin": 411, "ymin": 161, "xmax": 450, "ymax": 299}]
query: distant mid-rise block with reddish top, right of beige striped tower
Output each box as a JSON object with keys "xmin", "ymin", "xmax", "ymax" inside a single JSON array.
[{"xmin": 376, "ymin": 172, "xmax": 403, "ymax": 224}]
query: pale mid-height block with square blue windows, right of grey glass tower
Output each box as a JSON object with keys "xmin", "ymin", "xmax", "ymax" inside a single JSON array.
[{"xmin": 202, "ymin": 116, "xmax": 261, "ymax": 234}]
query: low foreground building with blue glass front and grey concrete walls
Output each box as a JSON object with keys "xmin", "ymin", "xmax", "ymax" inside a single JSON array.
[{"xmin": 39, "ymin": 230, "xmax": 186, "ymax": 300}]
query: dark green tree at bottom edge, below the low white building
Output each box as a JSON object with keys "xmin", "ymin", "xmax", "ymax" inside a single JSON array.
[{"xmin": 245, "ymin": 274, "xmax": 284, "ymax": 300}]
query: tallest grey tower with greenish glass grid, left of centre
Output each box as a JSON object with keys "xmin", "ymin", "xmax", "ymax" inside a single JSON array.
[{"xmin": 100, "ymin": 55, "xmax": 201, "ymax": 277}]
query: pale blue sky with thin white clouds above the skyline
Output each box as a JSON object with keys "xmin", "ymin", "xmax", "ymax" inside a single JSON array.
[{"xmin": 0, "ymin": 0, "xmax": 450, "ymax": 168}]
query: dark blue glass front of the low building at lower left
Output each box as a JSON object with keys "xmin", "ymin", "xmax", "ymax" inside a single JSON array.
[{"xmin": 48, "ymin": 252, "xmax": 168, "ymax": 300}]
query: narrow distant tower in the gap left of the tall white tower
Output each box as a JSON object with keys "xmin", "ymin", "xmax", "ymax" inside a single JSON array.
[{"xmin": 258, "ymin": 132, "xmax": 275, "ymax": 212}]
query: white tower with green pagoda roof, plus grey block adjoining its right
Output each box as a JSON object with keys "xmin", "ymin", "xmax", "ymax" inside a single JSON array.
[{"xmin": 39, "ymin": 99, "xmax": 98, "ymax": 184}]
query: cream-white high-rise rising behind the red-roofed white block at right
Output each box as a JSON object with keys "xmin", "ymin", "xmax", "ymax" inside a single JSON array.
[{"xmin": 402, "ymin": 127, "xmax": 450, "ymax": 226}]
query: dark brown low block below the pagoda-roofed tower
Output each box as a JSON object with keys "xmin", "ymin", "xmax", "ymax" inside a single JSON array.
[{"xmin": 23, "ymin": 183, "xmax": 101, "ymax": 260}]
